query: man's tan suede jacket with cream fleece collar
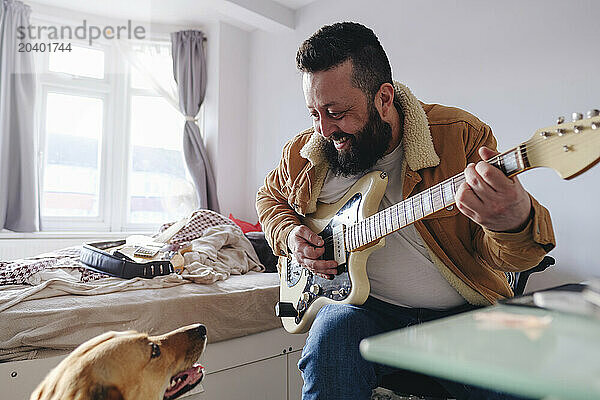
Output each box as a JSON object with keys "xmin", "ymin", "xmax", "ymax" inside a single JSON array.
[{"xmin": 256, "ymin": 82, "xmax": 555, "ymax": 305}]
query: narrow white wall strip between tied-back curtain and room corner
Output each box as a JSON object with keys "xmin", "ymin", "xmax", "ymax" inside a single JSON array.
[{"xmin": 204, "ymin": 22, "xmax": 256, "ymax": 222}]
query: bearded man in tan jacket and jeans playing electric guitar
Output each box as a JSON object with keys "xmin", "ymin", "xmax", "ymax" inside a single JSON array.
[{"xmin": 257, "ymin": 23, "xmax": 555, "ymax": 400}]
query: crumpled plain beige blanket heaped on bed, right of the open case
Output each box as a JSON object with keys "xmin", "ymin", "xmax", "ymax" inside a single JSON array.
[{"xmin": 181, "ymin": 225, "xmax": 265, "ymax": 284}]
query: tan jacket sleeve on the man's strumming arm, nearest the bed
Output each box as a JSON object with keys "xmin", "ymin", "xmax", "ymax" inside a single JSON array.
[{"xmin": 256, "ymin": 143, "xmax": 301, "ymax": 256}]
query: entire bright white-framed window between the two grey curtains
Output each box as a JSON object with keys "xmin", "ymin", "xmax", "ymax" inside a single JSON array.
[{"xmin": 36, "ymin": 41, "xmax": 196, "ymax": 231}]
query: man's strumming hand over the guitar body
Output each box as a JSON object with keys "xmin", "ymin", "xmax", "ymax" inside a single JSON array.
[{"xmin": 287, "ymin": 225, "xmax": 337, "ymax": 279}]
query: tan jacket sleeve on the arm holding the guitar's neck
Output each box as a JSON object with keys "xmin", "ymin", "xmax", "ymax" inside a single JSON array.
[{"xmin": 466, "ymin": 125, "xmax": 556, "ymax": 271}]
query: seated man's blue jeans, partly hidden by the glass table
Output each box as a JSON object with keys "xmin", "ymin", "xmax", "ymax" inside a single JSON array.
[{"xmin": 298, "ymin": 297, "xmax": 536, "ymax": 400}]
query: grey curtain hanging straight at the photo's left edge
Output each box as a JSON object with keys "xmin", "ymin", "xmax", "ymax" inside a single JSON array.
[{"xmin": 0, "ymin": 0, "xmax": 40, "ymax": 232}]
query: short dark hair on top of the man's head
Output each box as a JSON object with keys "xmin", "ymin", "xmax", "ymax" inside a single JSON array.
[{"xmin": 296, "ymin": 22, "xmax": 392, "ymax": 99}]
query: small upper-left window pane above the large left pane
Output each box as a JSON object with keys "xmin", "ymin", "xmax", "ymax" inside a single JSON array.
[{"xmin": 48, "ymin": 45, "xmax": 104, "ymax": 79}]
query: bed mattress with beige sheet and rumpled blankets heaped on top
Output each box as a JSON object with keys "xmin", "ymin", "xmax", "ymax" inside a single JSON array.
[{"xmin": 0, "ymin": 210, "xmax": 280, "ymax": 362}]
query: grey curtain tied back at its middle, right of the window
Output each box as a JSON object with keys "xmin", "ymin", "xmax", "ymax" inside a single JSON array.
[{"xmin": 171, "ymin": 30, "xmax": 219, "ymax": 212}]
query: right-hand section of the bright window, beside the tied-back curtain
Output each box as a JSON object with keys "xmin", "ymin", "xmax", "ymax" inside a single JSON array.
[{"xmin": 127, "ymin": 46, "xmax": 195, "ymax": 223}]
